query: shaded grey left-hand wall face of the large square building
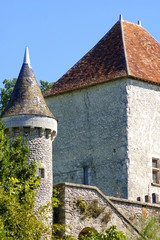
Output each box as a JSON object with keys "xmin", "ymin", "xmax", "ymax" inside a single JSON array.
[{"xmin": 46, "ymin": 80, "xmax": 128, "ymax": 198}]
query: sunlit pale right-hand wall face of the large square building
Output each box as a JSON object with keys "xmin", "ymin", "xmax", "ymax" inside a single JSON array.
[{"xmin": 127, "ymin": 80, "xmax": 160, "ymax": 201}]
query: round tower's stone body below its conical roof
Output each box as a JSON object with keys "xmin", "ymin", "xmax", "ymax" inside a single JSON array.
[{"xmin": 2, "ymin": 115, "xmax": 57, "ymax": 208}]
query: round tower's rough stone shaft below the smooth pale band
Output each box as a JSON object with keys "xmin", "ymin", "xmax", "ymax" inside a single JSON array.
[{"xmin": 6, "ymin": 127, "xmax": 53, "ymax": 208}]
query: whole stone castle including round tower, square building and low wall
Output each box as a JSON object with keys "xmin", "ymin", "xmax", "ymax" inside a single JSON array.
[{"xmin": 2, "ymin": 17, "xmax": 160, "ymax": 239}]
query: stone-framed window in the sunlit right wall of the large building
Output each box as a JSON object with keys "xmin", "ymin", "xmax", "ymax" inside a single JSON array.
[{"xmin": 152, "ymin": 157, "xmax": 160, "ymax": 185}]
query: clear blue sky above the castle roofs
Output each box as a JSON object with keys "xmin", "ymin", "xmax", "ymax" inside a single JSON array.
[{"xmin": 0, "ymin": 0, "xmax": 160, "ymax": 87}]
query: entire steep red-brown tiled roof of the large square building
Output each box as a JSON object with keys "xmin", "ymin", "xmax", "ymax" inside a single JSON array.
[{"xmin": 44, "ymin": 17, "xmax": 160, "ymax": 97}]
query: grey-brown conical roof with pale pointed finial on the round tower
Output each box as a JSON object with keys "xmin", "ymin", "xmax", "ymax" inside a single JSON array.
[{"xmin": 2, "ymin": 48, "xmax": 53, "ymax": 117}]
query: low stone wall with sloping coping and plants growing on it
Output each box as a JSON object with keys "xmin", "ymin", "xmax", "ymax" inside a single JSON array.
[{"xmin": 55, "ymin": 183, "xmax": 160, "ymax": 240}]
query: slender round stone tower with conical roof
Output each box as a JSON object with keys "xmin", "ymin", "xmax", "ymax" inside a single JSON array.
[{"xmin": 2, "ymin": 48, "xmax": 57, "ymax": 211}]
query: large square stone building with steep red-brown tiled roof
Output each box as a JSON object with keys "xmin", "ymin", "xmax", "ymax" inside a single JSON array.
[{"xmin": 44, "ymin": 15, "xmax": 160, "ymax": 202}]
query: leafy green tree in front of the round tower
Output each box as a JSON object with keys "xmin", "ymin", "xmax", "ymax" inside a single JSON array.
[{"xmin": 0, "ymin": 122, "xmax": 49, "ymax": 240}]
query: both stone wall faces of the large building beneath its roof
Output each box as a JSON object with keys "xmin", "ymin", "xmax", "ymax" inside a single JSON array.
[{"xmin": 46, "ymin": 79, "xmax": 160, "ymax": 201}]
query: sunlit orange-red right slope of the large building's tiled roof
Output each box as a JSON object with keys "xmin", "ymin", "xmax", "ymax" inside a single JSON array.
[{"xmin": 123, "ymin": 22, "xmax": 160, "ymax": 84}]
